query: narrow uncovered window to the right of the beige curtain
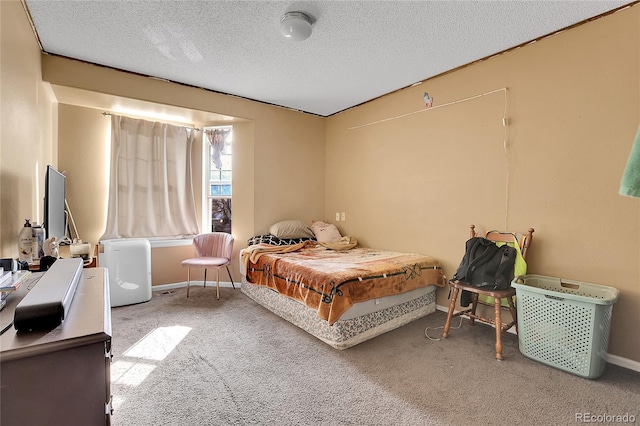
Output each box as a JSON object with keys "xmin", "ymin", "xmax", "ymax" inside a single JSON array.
[{"xmin": 203, "ymin": 126, "xmax": 233, "ymax": 233}]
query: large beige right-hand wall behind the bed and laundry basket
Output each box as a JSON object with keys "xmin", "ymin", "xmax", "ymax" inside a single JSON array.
[{"xmin": 325, "ymin": 6, "xmax": 640, "ymax": 361}]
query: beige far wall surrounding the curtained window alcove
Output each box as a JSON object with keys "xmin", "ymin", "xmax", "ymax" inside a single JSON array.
[{"xmin": 50, "ymin": 60, "xmax": 325, "ymax": 285}]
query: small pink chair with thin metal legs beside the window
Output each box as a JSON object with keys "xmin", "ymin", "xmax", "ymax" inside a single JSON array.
[{"xmin": 182, "ymin": 232, "xmax": 236, "ymax": 299}]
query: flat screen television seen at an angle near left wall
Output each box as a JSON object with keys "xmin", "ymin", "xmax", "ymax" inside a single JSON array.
[{"xmin": 43, "ymin": 166, "xmax": 67, "ymax": 242}]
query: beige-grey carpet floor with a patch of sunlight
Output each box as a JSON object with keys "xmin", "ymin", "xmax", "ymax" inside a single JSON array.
[{"xmin": 111, "ymin": 287, "xmax": 640, "ymax": 426}]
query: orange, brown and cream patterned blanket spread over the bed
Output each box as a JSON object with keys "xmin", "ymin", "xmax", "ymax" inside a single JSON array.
[{"xmin": 241, "ymin": 243, "xmax": 446, "ymax": 324}]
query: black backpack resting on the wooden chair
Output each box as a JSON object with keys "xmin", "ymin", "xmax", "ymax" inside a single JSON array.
[{"xmin": 453, "ymin": 237, "xmax": 516, "ymax": 307}]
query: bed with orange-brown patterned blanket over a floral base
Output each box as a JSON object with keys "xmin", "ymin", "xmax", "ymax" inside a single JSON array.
[{"xmin": 240, "ymin": 226, "xmax": 446, "ymax": 349}]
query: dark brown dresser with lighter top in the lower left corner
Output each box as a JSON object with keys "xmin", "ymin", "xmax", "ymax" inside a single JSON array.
[{"xmin": 0, "ymin": 268, "xmax": 112, "ymax": 426}]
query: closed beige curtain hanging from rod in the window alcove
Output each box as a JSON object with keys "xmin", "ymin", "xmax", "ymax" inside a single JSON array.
[{"xmin": 101, "ymin": 115, "xmax": 198, "ymax": 239}]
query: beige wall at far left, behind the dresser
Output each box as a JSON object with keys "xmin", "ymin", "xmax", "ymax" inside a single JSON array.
[{"xmin": 0, "ymin": 1, "xmax": 57, "ymax": 258}]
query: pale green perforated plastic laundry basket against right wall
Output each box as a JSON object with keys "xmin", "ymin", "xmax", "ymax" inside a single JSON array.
[{"xmin": 511, "ymin": 275, "xmax": 618, "ymax": 379}]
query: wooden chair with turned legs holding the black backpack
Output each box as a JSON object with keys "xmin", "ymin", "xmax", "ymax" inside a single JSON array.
[{"xmin": 442, "ymin": 225, "xmax": 534, "ymax": 361}]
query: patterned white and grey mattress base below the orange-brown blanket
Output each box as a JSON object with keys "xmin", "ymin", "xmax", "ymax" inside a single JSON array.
[{"xmin": 241, "ymin": 275, "xmax": 436, "ymax": 349}]
